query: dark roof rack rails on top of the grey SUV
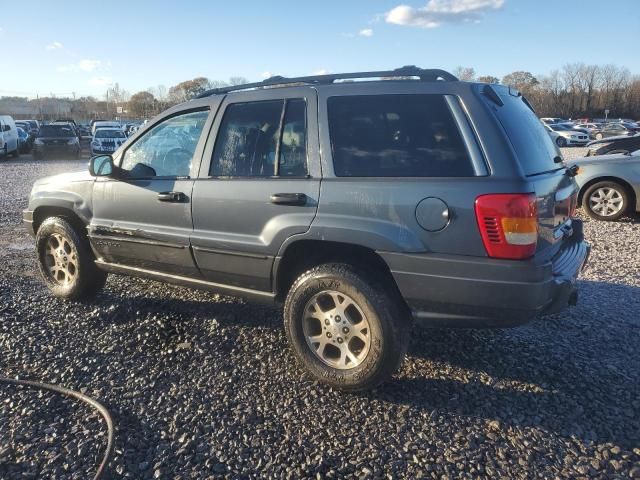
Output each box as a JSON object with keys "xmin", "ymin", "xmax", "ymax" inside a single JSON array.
[{"xmin": 196, "ymin": 65, "xmax": 458, "ymax": 98}]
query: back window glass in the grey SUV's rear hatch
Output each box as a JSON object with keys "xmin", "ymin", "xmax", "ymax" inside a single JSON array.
[{"xmin": 481, "ymin": 86, "xmax": 562, "ymax": 175}]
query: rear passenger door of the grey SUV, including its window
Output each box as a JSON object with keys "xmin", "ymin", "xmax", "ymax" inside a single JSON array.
[{"xmin": 191, "ymin": 87, "xmax": 320, "ymax": 291}]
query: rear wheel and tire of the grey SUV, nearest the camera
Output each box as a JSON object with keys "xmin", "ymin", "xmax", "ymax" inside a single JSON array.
[{"xmin": 284, "ymin": 263, "xmax": 411, "ymax": 391}]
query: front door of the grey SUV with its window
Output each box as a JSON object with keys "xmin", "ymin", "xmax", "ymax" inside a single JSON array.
[{"xmin": 89, "ymin": 107, "xmax": 211, "ymax": 277}]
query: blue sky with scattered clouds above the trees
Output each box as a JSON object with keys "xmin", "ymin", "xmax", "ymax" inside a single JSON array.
[{"xmin": 0, "ymin": 0, "xmax": 640, "ymax": 98}]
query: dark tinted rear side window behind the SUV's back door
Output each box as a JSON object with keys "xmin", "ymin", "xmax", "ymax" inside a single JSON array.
[{"xmin": 327, "ymin": 95, "xmax": 475, "ymax": 177}]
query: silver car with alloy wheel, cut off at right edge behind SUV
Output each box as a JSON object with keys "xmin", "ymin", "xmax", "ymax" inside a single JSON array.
[{"xmin": 571, "ymin": 150, "xmax": 640, "ymax": 220}]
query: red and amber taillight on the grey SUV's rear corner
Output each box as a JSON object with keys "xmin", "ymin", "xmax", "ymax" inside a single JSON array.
[{"xmin": 476, "ymin": 193, "xmax": 538, "ymax": 260}]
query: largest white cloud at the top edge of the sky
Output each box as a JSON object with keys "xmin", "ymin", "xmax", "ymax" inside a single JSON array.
[{"xmin": 385, "ymin": 0, "xmax": 505, "ymax": 28}]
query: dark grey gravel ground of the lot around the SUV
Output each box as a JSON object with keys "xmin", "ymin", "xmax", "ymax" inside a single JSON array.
[{"xmin": 0, "ymin": 149, "xmax": 640, "ymax": 478}]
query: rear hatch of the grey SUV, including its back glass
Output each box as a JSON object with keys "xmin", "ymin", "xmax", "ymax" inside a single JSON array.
[{"xmin": 479, "ymin": 85, "xmax": 578, "ymax": 258}]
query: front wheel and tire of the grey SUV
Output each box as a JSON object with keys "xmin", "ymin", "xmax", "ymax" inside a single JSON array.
[{"xmin": 36, "ymin": 217, "xmax": 107, "ymax": 300}]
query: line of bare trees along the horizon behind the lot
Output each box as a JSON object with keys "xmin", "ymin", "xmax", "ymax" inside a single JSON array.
[{"xmin": 0, "ymin": 63, "xmax": 640, "ymax": 120}]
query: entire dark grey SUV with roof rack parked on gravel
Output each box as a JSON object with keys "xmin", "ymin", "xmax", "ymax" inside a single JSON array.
[{"xmin": 24, "ymin": 67, "xmax": 589, "ymax": 390}]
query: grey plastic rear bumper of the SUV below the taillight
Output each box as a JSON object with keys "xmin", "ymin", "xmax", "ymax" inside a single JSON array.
[{"xmin": 379, "ymin": 220, "xmax": 591, "ymax": 328}]
